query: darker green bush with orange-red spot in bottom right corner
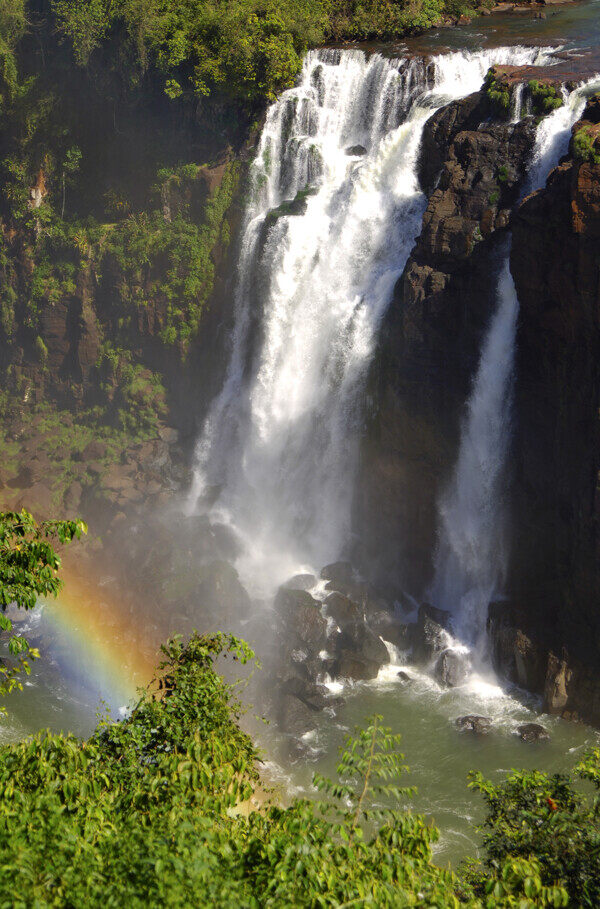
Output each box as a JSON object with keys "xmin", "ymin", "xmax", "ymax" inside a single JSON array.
[{"xmin": 469, "ymin": 748, "xmax": 600, "ymax": 907}]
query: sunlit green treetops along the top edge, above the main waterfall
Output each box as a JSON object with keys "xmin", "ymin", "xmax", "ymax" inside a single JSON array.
[{"xmin": 52, "ymin": 0, "xmax": 488, "ymax": 102}]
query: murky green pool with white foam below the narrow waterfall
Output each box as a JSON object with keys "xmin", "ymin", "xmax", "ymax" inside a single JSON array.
[{"xmin": 258, "ymin": 666, "xmax": 600, "ymax": 865}]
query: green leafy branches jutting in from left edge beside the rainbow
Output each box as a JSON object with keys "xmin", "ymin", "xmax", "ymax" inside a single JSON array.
[{"xmin": 0, "ymin": 509, "xmax": 87, "ymax": 695}]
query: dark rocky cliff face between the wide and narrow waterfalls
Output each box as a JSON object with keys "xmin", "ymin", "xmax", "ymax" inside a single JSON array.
[{"xmin": 358, "ymin": 85, "xmax": 534, "ymax": 595}]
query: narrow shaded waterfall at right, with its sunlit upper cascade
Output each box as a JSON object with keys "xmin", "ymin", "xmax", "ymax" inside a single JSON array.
[{"xmin": 431, "ymin": 76, "xmax": 596, "ymax": 646}]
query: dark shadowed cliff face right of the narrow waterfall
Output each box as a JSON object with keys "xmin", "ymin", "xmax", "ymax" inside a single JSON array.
[{"xmin": 511, "ymin": 101, "xmax": 600, "ymax": 662}]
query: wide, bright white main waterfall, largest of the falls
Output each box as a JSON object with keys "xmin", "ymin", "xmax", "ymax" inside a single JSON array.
[{"xmin": 190, "ymin": 47, "xmax": 547, "ymax": 595}]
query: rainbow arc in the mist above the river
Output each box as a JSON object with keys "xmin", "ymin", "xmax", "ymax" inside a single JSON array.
[{"xmin": 41, "ymin": 569, "xmax": 159, "ymax": 710}]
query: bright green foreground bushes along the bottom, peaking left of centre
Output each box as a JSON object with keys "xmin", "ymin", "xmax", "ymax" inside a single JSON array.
[{"xmin": 0, "ymin": 612, "xmax": 600, "ymax": 909}]
